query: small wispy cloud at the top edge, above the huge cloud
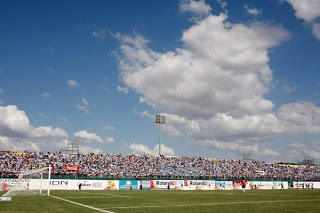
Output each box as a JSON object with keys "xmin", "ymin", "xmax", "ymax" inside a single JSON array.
[{"xmin": 179, "ymin": 0, "xmax": 211, "ymax": 16}]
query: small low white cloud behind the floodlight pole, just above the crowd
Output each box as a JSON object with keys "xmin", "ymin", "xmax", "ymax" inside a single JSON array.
[{"xmin": 129, "ymin": 143, "xmax": 174, "ymax": 156}]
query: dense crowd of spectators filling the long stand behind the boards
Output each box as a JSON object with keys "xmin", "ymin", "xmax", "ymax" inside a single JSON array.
[{"xmin": 0, "ymin": 151, "xmax": 320, "ymax": 180}]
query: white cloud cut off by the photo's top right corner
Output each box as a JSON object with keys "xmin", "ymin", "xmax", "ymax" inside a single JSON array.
[{"xmin": 287, "ymin": 0, "xmax": 320, "ymax": 22}]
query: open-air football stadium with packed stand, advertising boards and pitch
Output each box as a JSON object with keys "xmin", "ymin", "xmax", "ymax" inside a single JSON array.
[{"xmin": 0, "ymin": 151, "xmax": 320, "ymax": 212}]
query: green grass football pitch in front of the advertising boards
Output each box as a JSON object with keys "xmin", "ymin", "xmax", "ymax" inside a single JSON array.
[{"xmin": 0, "ymin": 190, "xmax": 320, "ymax": 213}]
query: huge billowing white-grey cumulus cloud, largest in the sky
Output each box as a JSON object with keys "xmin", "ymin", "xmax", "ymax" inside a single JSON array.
[{"xmin": 116, "ymin": 8, "xmax": 320, "ymax": 157}]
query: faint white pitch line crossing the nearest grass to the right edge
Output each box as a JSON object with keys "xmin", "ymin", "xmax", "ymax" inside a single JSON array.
[{"xmin": 102, "ymin": 199, "xmax": 320, "ymax": 209}]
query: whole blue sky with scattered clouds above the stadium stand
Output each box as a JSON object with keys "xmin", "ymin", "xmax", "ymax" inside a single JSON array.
[{"xmin": 0, "ymin": 0, "xmax": 320, "ymax": 163}]
